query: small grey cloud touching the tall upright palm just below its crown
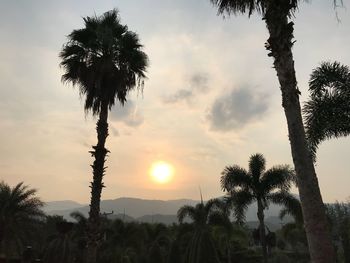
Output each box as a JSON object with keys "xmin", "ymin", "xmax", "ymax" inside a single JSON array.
[{"xmin": 111, "ymin": 100, "xmax": 144, "ymax": 127}]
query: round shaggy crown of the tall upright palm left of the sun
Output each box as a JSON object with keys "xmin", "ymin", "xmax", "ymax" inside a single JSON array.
[{"xmin": 59, "ymin": 9, "xmax": 148, "ymax": 115}]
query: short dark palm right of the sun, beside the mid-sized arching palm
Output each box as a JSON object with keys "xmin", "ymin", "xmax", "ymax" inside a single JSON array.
[{"xmin": 177, "ymin": 199, "xmax": 221, "ymax": 263}]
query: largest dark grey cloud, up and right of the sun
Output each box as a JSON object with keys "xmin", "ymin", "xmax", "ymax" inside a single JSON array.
[{"xmin": 207, "ymin": 88, "xmax": 268, "ymax": 131}]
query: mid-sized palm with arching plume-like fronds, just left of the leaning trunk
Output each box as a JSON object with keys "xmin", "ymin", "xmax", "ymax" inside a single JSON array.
[{"xmin": 221, "ymin": 154, "xmax": 299, "ymax": 262}]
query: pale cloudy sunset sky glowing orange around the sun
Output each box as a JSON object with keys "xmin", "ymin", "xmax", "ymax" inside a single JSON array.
[{"xmin": 0, "ymin": 0, "xmax": 350, "ymax": 203}]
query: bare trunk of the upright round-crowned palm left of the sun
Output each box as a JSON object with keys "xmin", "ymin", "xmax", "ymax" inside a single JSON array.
[{"xmin": 86, "ymin": 103, "xmax": 108, "ymax": 263}]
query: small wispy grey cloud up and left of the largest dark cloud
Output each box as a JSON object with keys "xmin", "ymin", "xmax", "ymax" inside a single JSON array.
[{"xmin": 163, "ymin": 73, "xmax": 209, "ymax": 104}]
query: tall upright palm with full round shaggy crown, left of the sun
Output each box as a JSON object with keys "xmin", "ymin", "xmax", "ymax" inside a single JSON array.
[{"xmin": 60, "ymin": 9, "xmax": 148, "ymax": 262}]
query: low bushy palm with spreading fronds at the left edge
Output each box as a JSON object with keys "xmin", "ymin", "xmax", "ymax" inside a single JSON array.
[{"xmin": 0, "ymin": 181, "xmax": 44, "ymax": 256}]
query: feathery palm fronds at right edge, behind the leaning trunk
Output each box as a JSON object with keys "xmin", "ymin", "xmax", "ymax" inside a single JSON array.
[{"xmin": 303, "ymin": 62, "xmax": 350, "ymax": 160}]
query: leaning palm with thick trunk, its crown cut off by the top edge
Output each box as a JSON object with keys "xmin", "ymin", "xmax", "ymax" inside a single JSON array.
[{"xmin": 210, "ymin": 0, "xmax": 337, "ymax": 262}]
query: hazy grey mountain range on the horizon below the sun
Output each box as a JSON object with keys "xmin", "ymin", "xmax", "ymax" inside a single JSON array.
[{"xmin": 45, "ymin": 198, "xmax": 291, "ymax": 229}]
